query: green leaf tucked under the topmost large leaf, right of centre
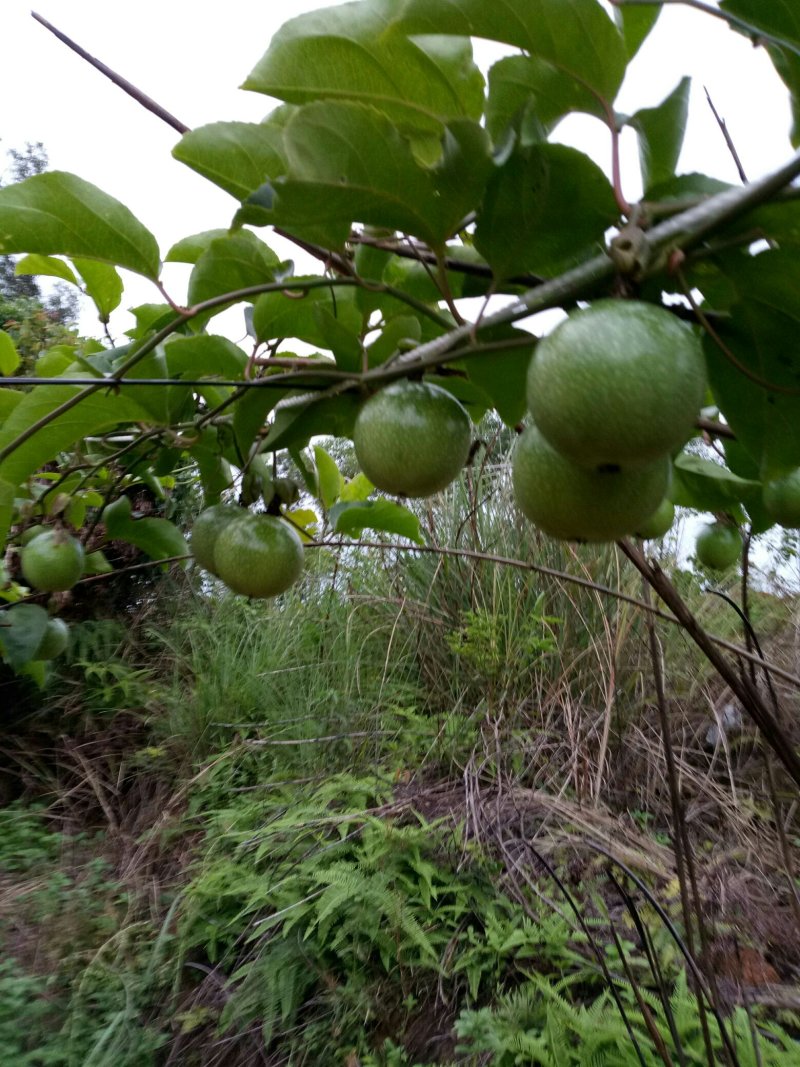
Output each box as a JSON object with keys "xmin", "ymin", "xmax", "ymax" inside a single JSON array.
[{"xmin": 486, "ymin": 55, "xmax": 606, "ymax": 143}]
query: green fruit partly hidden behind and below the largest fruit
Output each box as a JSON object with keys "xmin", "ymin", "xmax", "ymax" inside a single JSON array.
[{"xmin": 512, "ymin": 426, "xmax": 671, "ymax": 541}]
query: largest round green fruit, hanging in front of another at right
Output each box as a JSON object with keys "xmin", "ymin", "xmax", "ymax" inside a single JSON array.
[{"xmin": 527, "ymin": 300, "xmax": 705, "ymax": 467}]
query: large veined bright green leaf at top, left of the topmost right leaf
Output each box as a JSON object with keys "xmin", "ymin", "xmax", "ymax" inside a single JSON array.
[{"xmin": 243, "ymin": 0, "xmax": 483, "ymax": 134}]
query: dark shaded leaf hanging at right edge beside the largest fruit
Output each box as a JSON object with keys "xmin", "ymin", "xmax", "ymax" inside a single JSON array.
[{"xmin": 704, "ymin": 249, "xmax": 800, "ymax": 480}]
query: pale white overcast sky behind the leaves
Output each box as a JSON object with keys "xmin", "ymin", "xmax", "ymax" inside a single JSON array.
[{"xmin": 0, "ymin": 0, "xmax": 791, "ymax": 331}]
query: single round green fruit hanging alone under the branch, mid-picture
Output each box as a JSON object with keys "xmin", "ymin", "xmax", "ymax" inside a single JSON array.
[{"xmin": 353, "ymin": 381, "xmax": 473, "ymax": 496}]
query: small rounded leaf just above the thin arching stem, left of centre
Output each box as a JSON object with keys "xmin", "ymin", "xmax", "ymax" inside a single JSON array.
[{"xmin": 189, "ymin": 229, "xmax": 281, "ymax": 315}]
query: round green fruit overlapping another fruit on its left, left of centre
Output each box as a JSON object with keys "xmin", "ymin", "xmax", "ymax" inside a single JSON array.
[{"xmin": 213, "ymin": 514, "xmax": 303, "ymax": 598}]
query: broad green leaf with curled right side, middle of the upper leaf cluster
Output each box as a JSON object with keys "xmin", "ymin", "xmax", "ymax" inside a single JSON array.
[{"xmin": 273, "ymin": 101, "xmax": 489, "ymax": 248}]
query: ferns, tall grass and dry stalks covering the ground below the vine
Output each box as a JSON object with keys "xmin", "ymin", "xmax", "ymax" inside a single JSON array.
[{"xmin": 0, "ymin": 457, "xmax": 800, "ymax": 1067}]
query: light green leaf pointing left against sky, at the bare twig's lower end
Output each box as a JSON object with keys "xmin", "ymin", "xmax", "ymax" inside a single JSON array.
[{"xmin": 172, "ymin": 122, "xmax": 286, "ymax": 201}]
